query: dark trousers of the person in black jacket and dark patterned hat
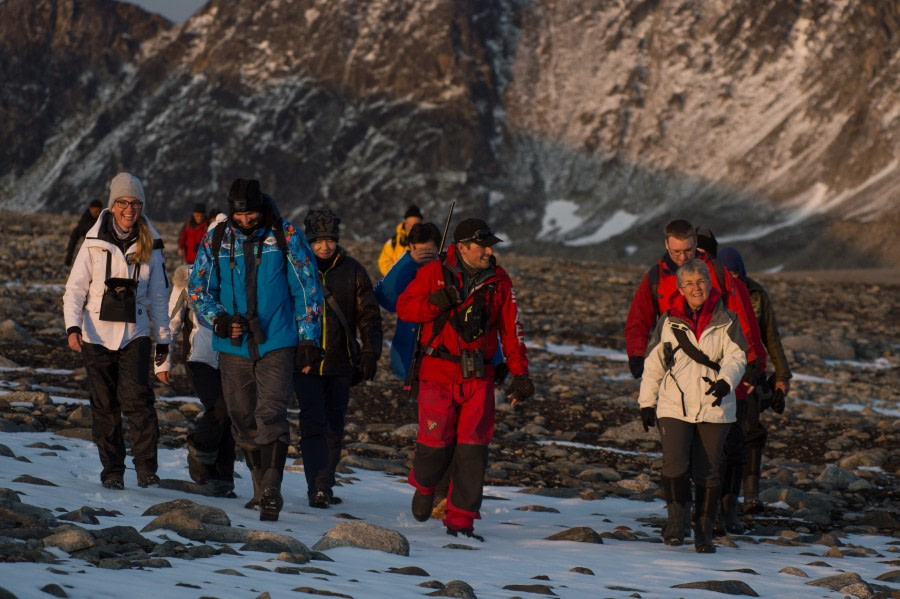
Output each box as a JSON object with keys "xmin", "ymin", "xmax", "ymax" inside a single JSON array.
[{"xmin": 294, "ymin": 370, "xmax": 350, "ymax": 496}]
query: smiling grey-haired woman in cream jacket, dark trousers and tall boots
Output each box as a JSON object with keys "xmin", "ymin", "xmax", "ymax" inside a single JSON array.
[{"xmin": 639, "ymin": 260, "xmax": 747, "ymax": 553}]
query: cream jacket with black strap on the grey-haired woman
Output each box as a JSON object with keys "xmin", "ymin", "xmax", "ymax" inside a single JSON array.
[{"xmin": 638, "ymin": 294, "xmax": 747, "ymax": 423}]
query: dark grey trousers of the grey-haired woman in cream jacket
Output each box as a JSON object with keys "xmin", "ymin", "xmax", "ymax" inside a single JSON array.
[{"xmin": 659, "ymin": 418, "xmax": 731, "ymax": 488}]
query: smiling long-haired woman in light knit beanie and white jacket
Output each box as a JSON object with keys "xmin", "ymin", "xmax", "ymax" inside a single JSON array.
[{"xmin": 63, "ymin": 173, "xmax": 170, "ymax": 489}]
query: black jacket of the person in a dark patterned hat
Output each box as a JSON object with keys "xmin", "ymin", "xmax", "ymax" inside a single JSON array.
[{"xmin": 317, "ymin": 246, "xmax": 383, "ymax": 376}]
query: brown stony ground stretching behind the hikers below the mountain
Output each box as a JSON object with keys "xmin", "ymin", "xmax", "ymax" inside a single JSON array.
[{"xmin": 0, "ymin": 213, "xmax": 900, "ymax": 536}]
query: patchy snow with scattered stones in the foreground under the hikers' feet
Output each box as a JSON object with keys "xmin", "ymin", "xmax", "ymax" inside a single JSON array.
[{"xmin": 0, "ymin": 433, "xmax": 897, "ymax": 599}]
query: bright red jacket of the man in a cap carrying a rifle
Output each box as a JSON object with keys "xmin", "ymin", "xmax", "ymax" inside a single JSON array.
[{"xmin": 397, "ymin": 246, "xmax": 528, "ymax": 384}]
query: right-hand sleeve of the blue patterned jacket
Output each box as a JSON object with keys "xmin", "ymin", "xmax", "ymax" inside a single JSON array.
[{"xmin": 284, "ymin": 221, "xmax": 324, "ymax": 346}]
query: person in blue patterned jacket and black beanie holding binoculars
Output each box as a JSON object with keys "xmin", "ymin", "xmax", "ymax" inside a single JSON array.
[{"xmin": 188, "ymin": 179, "xmax": 323, "ymax": 520}]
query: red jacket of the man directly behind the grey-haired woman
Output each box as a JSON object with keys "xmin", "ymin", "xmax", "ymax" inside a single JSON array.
[{"xmin": 625, "ymin": 252, "xmax": 766, "ymax": 372}]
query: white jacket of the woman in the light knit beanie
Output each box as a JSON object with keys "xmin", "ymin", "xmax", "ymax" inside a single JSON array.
[{"xmin": 63, "ymin": 210, "xmax": 171, "ymax": 372}]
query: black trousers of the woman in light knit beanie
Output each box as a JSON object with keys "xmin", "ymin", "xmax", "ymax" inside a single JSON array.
[{"xmin": 81, "ymin": 337, "xmax": 159, "ymax": 480}]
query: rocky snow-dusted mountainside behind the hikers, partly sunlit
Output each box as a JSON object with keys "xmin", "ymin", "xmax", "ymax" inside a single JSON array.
[{"xmin": 0, "ymin": 0, "xmax": 900, "ymax": 267}]
